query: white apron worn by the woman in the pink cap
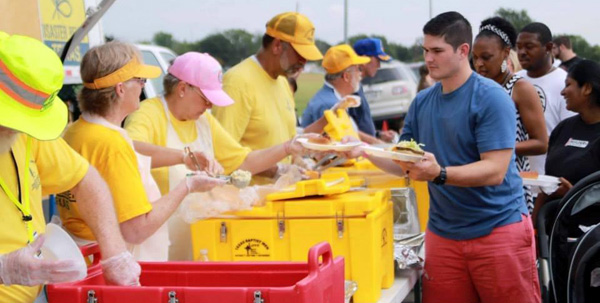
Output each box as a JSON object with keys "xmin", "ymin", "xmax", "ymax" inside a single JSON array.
[{"xmin": 160, "ymin": 97, "xmax": 214, "ymax": 261}]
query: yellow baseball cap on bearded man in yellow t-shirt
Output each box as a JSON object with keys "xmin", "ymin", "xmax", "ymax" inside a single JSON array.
[{"xmin": 267, "ymin": 12, "xmax": 323, "ymax": 61}]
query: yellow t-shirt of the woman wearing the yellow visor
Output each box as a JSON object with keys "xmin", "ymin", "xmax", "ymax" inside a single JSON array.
[{"xmin": 56, "ymin": 119, "xmax": 152, "ymax": 240}]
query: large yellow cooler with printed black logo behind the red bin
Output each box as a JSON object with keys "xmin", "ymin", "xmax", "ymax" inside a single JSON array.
[{"xmin": 191, "ymin": 189, "xmax": 394, "ymax": 303}]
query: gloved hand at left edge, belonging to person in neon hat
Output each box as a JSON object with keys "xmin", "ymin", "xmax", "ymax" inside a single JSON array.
[{"xmin": 0, "ymin": 235, "xmax": 79, "ymax": 286}]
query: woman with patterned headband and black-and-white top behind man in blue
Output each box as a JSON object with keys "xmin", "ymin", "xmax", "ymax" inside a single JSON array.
[{"xmin": 473, "ymin": 17, "xmax": 548, "ymax": 213}]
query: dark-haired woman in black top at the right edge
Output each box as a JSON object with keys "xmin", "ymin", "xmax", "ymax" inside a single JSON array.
[{"xmin": 534, "ymin": 60, "xmax": 600, "ymax": 221}]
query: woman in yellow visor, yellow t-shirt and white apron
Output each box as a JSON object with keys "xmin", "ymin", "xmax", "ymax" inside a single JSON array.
[{"xmin": 58, "ymin": 41, "xmax": 224, "ymax": 261}]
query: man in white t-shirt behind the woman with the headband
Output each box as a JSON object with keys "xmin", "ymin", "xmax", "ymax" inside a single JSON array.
[{"xmin": 517, "ymin": 22, "xmax": 575, "ymax": 175}]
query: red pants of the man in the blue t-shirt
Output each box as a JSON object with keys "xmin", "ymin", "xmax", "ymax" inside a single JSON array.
[{"xmin": 423, "ymin": 216, "xmax": 541, "ymax": 303}]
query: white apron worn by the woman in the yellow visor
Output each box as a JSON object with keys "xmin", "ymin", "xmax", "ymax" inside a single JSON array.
[{"xmin": 75, "ymin": 113, "xmax": 169, "ymax": 261}]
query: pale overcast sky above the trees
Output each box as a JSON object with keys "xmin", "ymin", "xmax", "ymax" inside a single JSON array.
[{"xmin": 102, "ymin": 0, "xmax": 600, "ymax": 45}]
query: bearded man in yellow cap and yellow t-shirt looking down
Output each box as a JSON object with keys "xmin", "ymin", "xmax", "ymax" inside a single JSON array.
[{"xmin": 212, "ymin": 12, "xmax": 323, "ymax": 154}]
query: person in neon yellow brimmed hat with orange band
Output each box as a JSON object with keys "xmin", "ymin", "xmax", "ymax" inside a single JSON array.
[{"xmin": 0, "ymin": 32, "xmax": 140, "ymax": 302}]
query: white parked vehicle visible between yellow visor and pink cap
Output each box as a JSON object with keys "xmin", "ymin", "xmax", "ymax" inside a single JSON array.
[{"xmin": 135, "ymin": 44, "xmax": 177, "ymax": 100}]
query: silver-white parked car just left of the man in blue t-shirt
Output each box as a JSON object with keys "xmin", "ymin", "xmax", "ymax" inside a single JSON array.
[{"xmin": 362, "ymin": 61, "xmax": 417, "ymax": 122}]
